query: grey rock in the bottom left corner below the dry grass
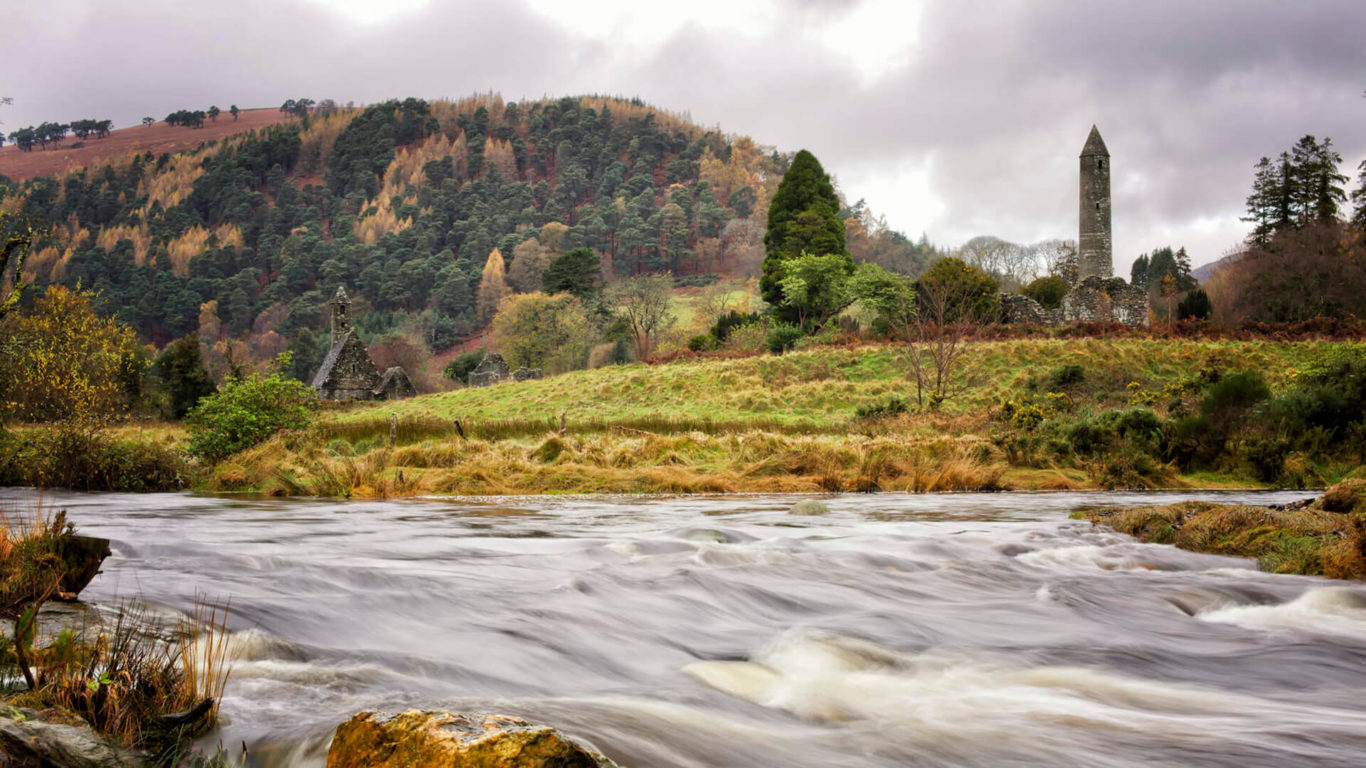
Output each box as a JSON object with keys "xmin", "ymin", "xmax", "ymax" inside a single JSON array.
[{"xmin": 0, "ymin": 704, "xmax": 138, "ymax": 768}]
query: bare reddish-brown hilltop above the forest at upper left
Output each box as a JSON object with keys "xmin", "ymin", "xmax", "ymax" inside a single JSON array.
[{"xmin": 0, "ymin": 109, "xmax": 295, "ymax": 182}]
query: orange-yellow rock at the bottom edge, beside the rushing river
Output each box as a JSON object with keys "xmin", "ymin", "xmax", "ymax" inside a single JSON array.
[{"xmin": 328, "ymin": 709, "xmax": 616, "ymax": 768}]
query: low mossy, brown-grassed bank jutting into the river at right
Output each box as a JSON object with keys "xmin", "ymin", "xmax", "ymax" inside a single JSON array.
[{"xmin": 1076, "ymin": 470, "xmax": 1366, "ymax": 581}]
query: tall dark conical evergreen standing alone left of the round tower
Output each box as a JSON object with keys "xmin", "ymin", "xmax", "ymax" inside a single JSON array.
[{"xmin": 759, "ymin": 149, "xmax": 854, "ymax": 315}]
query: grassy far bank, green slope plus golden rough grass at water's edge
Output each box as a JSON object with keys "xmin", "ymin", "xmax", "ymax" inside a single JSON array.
[{"xmin": 192, "ymin": 339, "xmax": 1329, "ymax": 496}]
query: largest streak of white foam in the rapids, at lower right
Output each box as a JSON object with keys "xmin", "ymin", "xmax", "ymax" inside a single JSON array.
[{"xmin": 683, "ymin": 634, "xmax": 1366, "ymax": 746}]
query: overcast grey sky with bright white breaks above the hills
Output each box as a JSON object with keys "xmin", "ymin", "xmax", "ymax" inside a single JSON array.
[{"xmin": 0, "ymin": 0, "xmax": 1366, "ymax": 275}]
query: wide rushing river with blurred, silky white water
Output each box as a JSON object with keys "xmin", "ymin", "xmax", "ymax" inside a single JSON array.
[{"xmin": 7, "ymin": 492, "xmax": 1366, "ymax": 768}]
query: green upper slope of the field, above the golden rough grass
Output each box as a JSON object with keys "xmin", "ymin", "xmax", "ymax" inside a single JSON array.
[{"xmin": 329, "ymin": 339, "xmax": 1332, "ymax": 428}]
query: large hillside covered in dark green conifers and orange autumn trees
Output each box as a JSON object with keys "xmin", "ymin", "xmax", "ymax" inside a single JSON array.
[{"xmin": 0, "ymin": 94, "xmax": 930, "ymax": 377}]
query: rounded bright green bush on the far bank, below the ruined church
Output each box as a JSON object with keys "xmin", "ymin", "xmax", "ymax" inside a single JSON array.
[{"xmin": 186, "ymin": 355, "xmax": 317, "ymax": 462}]
